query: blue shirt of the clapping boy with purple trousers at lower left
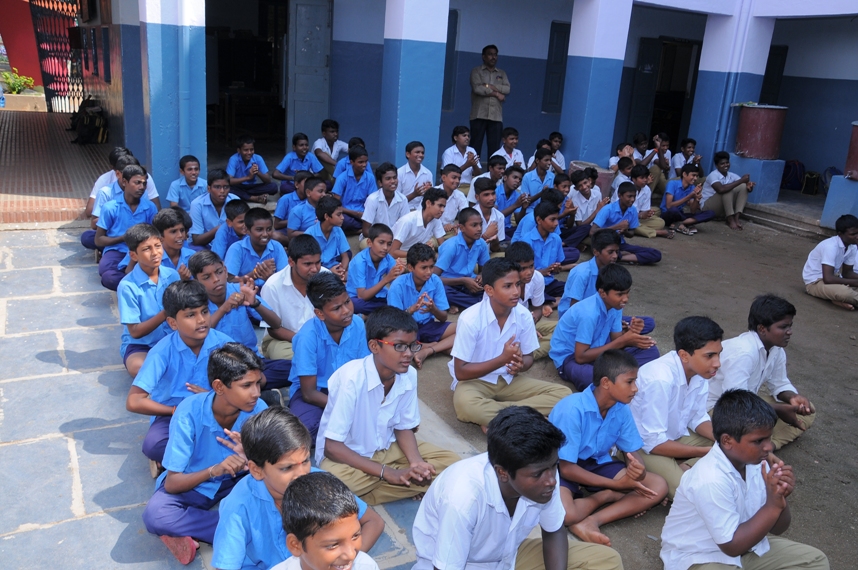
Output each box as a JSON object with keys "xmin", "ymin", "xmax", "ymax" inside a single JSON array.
[{"xmin": 158, "ymin": 390, "xmax": 268, "ymax": 496}]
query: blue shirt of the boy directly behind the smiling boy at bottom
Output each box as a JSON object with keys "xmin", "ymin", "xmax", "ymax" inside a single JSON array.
[{"xmin": 212, "ymin": 467, "xmax": 367, "ymax": 570}]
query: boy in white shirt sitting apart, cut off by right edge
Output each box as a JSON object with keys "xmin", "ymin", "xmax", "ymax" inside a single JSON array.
[{"xmin": 801, "ymin": 214, "xmax": 858, "ymax": 311}]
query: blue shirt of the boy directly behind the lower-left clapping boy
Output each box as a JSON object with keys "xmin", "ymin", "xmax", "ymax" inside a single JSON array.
[{"xmin": 132, "ymin": 329, "xmax": 233, "ymax": 408}]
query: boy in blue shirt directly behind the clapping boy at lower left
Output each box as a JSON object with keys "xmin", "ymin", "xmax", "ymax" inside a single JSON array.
[{"xmin": 125, "ymin": 281, "xmax": 233, "ymax": 466}]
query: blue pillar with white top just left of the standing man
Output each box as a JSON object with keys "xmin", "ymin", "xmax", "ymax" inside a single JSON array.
[{"xmin": 379, "ymin": 0, "xmax": 450, "ymax": 172}]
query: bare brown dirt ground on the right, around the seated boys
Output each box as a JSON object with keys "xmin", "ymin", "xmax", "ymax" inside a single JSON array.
[{"xmin": 412, "ymin": 222, "xmax": 858, "ymax": 570}]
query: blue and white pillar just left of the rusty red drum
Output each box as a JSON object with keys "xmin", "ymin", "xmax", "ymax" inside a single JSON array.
[{"xmin": 688, "ymin": 5, "xmax": 775, "ymax": 172}]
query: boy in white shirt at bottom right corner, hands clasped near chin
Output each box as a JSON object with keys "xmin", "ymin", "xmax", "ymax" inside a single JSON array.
[{"xmin": 661, "ymin": 390, "xmax": 829, "ymax": 570}]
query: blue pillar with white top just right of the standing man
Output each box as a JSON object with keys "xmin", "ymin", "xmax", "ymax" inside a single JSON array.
[{"xmin": 560, "ymin": 0, "xmax": 632, "ymax": 165}]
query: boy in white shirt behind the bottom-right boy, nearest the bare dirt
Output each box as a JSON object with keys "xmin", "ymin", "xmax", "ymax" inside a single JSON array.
[{"xmin": 706, "ymin": 295, "xmax": 816, "ymax": 449}]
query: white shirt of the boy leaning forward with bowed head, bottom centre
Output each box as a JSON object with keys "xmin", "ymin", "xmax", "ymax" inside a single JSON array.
[{"xmin": 412, "ymin": 453, "xmax": 565, "ymax": 570}]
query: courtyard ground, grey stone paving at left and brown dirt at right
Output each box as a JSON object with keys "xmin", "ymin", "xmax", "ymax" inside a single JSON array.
[{"xmin": 0, "ymin": 219, "xmax": 858, "ymax": 570}]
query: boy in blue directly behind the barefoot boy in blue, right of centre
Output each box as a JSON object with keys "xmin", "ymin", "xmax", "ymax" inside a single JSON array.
[{"xmin": 549, "ymin": 263, "xmax": 659, "ymax": 392}]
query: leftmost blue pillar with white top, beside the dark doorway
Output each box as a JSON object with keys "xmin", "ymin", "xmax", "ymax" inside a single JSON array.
[{"xmin": 140, "ymin": 0, "xmax": 207, "ymax": 199}]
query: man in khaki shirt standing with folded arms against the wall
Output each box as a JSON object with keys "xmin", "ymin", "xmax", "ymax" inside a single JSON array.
[{"xmin": 471, "ymin": 45, "xmax": 509, "ymax": 156}]
